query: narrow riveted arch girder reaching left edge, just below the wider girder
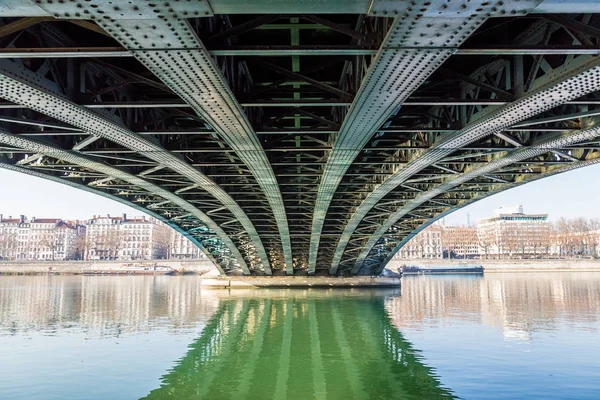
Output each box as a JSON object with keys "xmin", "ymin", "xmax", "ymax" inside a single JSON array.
[{"xmin": 0, "ymin": 130, "xmax": 250, "ymax": 275}]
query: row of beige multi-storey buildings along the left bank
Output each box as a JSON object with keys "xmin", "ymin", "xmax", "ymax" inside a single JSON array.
[{"xmin": 0, "ymin": 214, "xmax": 206, "ymax": 260}]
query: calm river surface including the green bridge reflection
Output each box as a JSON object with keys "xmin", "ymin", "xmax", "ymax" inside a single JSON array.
[{"xmin": 0, "ymin": 273, "xmax": 600, "ymax": 400}]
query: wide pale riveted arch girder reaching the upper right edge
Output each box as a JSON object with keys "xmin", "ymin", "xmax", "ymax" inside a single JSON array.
[{"xmin": 330, "ymin": 57, "xmax": 600, "ymax": 274}]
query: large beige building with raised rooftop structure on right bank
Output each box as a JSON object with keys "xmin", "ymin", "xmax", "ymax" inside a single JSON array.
[{"xmin": 477, "ymin": 206, "xmax": 550, "ymax": 258}]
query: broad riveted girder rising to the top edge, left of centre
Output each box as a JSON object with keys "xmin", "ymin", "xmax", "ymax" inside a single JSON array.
[{"xmin": 34, "ymin": 0, "xmax": 293, "ymax": 274}]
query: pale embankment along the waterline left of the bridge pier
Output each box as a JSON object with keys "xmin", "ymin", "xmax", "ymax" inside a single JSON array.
[{"xmin": 0, "ymin": 260, "xmax": 216, "ymax": 275}]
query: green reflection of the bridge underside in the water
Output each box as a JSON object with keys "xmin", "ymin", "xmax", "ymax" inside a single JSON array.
[{"xmin": 146, "ymin": 291, "xmax": 454, "ymax": 399}]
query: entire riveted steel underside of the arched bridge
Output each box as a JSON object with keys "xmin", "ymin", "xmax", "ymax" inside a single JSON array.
[{"xmin": 0, "ymin": 0, "xmax": 600, "ymax": 275}]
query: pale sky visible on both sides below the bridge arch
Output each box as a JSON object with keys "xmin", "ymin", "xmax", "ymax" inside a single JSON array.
[{"xmin": 0, "ymin": 165, "xmax": 600, "ymax": 225}]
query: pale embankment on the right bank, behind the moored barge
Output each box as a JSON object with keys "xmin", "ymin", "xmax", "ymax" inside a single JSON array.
[{"xmin": 388, "ymin": 259, "xmax": 600, "ymax": 273}]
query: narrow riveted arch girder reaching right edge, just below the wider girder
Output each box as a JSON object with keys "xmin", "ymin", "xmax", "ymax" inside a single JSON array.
[{"xmin": 355, "ymin": 126, "xmax": 600, "ymax": 269}]
